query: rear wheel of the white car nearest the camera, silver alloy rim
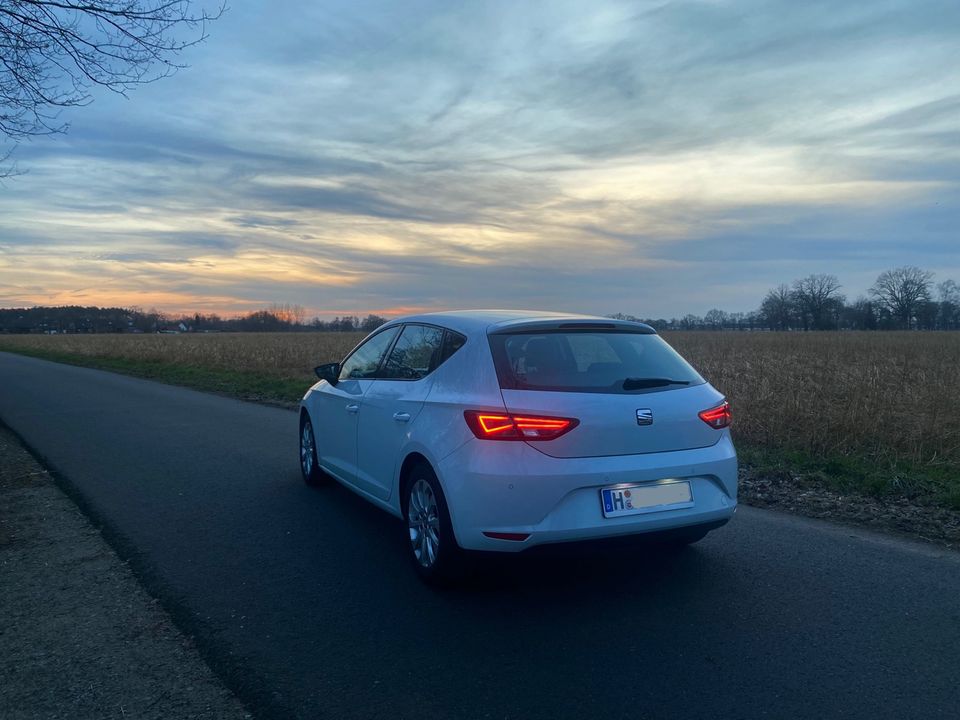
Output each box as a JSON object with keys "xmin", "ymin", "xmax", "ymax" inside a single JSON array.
[{"xmin": 402, "ymin": 463, "xmax": 464, "ymax": 585}]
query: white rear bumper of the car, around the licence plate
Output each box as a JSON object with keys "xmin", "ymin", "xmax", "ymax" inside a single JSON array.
[{"xmin": 436, "ymin": 431, "xmax": 737, "ymax": 552}]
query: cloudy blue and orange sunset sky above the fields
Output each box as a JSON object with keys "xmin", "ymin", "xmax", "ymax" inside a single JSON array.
[{"xmin": 0, "ymin": 0, "xmax": 960, "ymax": 317}]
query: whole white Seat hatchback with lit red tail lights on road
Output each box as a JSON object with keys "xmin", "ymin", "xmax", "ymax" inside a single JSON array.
[{"xmin": 300, "ymin": 310, "xmax": 737, "ymax": 580}]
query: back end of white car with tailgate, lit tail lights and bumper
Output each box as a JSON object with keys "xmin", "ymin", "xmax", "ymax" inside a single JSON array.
[{"xmin": 438, "ymin": 319, "xmax": 737, "ymax": 551}]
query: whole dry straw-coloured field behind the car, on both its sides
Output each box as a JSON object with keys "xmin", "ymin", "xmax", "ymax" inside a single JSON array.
[{"xmin": 0, "ymin": 332, "xmax": 960, "ymax": 504}]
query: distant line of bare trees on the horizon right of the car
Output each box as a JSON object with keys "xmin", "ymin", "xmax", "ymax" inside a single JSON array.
[{"xmin": 612, "ymin": 266, "xmax": 960, "ymax": 330}]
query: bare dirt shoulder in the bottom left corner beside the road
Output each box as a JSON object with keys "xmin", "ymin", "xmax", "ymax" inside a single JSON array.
[{"xmin": 0, "ymin": 428, "xmax": 250, "ymax": 720}]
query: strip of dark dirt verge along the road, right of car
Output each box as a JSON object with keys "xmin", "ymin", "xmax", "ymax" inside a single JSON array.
[{"xmin": 740, "ymin": 467, "xmax": 960, "ymax": 550}]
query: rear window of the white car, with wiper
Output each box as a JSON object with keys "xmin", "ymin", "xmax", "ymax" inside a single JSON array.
[{"xmin": 490, "ymin": 331, "xmax": 705, "ymax": 394}]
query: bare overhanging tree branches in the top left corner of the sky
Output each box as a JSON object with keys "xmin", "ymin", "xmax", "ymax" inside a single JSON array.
[{"xmin": 0, "ymin": 0, "xmax": 224, "ymax": 172}]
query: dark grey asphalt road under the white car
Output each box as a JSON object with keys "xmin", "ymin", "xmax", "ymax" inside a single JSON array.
[{"xmin": 0, "ymin": 353, "xmax": 960, "ymax": 720}]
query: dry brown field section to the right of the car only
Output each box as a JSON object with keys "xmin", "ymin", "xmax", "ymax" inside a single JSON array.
[{"xmin": 666, "ymin": 332, "xmax": 960, "ymax": 466}]
